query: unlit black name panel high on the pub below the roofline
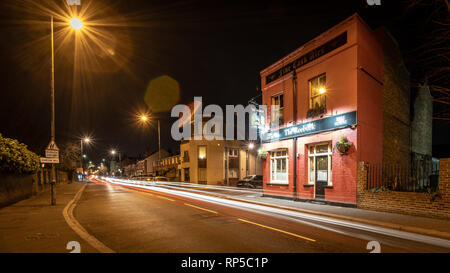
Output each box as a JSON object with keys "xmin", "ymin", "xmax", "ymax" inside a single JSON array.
[{"xmin": 266, "ymin": 32, "xmax": 347, "ymax": 84}]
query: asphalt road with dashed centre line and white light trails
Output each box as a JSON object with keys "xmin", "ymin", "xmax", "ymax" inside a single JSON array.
[{"xmin": 70, "ymin": 176, "xmax": 450, "ymax": 253}]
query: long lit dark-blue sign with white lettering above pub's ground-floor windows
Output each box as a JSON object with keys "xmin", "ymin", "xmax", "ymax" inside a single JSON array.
[{"xmin": 261, "ymin": 111, "xmax": 356, "ymax": 142}]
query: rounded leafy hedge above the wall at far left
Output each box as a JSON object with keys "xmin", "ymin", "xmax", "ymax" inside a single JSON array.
[{"xmin": 0, "ymin": 134, "xmax": 40, "ymax": 174}]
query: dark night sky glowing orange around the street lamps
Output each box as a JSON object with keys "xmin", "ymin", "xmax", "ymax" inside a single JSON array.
[{"xmin": 0, "ymin": 0, "xmax": 450, "ymax": 164}]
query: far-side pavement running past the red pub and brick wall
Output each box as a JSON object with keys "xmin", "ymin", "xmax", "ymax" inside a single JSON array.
[{"xmin": 149, "ymin": 182, "xmax": 450, "ymax": 239}]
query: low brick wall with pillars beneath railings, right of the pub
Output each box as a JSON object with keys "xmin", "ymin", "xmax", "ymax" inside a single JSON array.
[{"xmin": 357, "ymin": 158, "xmax": 450, "ymax": 219}]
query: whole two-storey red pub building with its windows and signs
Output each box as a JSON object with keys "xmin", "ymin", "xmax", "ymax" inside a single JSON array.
[{"xmin": 260, "ymin": 14, "xmax": 409, "ymax": 206}]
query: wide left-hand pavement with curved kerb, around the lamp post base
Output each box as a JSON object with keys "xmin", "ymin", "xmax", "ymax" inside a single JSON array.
[{"xmin": 0, "ymin": 182, "xmax": 98, "ymax": 253}]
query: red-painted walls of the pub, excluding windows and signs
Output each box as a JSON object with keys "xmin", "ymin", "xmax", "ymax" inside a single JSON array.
[{"xmin": 261, "ymin": 15, "xmax": 376, "ymax": 204}]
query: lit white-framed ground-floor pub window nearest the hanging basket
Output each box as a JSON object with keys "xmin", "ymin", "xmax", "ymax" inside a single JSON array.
[{"xmin": 308, "ymin": 143, "xmax": 332, "ymax": 186}]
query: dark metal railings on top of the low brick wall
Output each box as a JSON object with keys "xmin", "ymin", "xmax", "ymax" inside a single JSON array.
[{"xmin": 366, "ymin": 160, "xmax": 439, "ymax": 192}]
